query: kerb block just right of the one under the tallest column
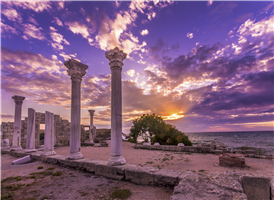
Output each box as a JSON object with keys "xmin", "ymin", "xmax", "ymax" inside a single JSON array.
[{"xmin": 125, "ymin": 165, "xmax": 159, "ymax": 185}]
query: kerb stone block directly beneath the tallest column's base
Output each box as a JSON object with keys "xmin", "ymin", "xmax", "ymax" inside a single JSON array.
[{"xmin": 95, "ymin": 161, "xmax": 127, "ymax": 180}]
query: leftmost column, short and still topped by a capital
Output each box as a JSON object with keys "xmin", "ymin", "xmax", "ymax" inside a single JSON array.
[{"xmin": 11, "ymin": 95, "xmax": 25, "ymax": 150}]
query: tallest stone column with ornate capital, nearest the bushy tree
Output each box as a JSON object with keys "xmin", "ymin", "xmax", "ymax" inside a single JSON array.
[{"xmin": 106, "ymin": 47, "xmax": 127, "ymax": 166}]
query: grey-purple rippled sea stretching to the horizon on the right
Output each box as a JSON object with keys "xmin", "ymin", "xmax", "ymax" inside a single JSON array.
[{"xmin": 185, "ymin": 131, "xmax": 274, "ymax": 154}]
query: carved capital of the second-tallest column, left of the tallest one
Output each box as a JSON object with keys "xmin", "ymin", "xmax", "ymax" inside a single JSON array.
[{"xmin": 64, "ymin": 59, "xmax": 88, "ymax": 82}]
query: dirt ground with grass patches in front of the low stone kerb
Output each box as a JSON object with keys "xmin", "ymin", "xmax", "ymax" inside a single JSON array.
[{"xmin": 0, "ymin": 154, "xmax": 173, "ymax": 200}]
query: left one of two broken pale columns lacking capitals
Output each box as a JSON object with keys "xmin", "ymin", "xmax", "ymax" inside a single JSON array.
[{"xmin": 25, "ymin": 108, "xmax": 36, "ymax": 152}]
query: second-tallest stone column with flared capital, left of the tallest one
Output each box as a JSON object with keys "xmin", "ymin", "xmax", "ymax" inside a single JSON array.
[{"xmin": 64, "ymin": 59, "xmax": 88, "ymax": 160}]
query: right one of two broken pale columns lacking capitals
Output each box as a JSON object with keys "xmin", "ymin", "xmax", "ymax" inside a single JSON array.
[{"xmin": 43, "ymin": 111, "xmax": 56, "ymax": 156}]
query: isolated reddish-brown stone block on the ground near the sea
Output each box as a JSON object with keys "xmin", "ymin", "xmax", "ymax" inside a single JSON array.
[{"xmin": 219, "ymin": 153, "xmax": 245, "ymax": 167}]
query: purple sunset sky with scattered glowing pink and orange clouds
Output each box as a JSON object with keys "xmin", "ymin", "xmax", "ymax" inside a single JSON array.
[{"xmin": 0, "ymin": 0, "xmax": 274, "ymax": 133}]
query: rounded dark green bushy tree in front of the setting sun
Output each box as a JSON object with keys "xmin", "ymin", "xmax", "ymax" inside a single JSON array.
[{"xmin": 129, "ymin": 114, "xmax": 192, "ymax": 146}]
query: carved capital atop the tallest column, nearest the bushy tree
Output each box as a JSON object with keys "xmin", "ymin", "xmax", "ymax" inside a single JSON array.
[{"xmin": 106, "ymin": 47, "xmax": 127, "ymax": 69}]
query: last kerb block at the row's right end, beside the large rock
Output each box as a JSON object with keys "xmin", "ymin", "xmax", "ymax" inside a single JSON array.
[{"xmin": 153, "ymin": 169, "xmax": 182, "ymax": 186}]
